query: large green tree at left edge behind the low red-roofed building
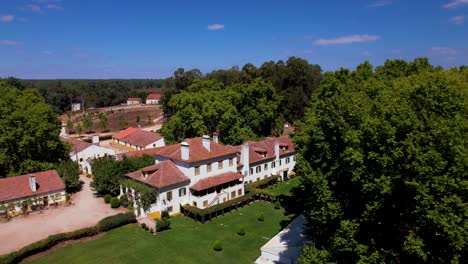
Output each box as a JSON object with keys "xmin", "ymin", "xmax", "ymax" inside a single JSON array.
[{"xmin": 0, "ymin": 81, "xmax": 68, "ymax": 177}]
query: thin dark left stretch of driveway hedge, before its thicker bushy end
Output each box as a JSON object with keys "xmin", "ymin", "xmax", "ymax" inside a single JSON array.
[{"xmin": 0, "ymin": 227, "xmax": 99, "ymax": 264}]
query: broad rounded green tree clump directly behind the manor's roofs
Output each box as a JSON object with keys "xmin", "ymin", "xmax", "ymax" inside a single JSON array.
[{"xmin": 162, "ymin": 79, "xmax": 283, "ymax": 144}]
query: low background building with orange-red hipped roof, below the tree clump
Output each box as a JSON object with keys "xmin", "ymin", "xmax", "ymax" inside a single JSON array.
[{"xmin": 112, "ymin": 127, "xmax": 165, "ymax": 150}]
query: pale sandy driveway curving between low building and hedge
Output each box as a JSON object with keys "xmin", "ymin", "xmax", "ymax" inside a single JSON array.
[{"xmin": 0, "ymin": 176, "xmax": 128, "ymax": 255}]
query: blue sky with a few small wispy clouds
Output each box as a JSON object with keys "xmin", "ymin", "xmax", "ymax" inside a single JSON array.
[{"xmin": 0, "ymin": 0, "xmax": 468, "ymax": 79}]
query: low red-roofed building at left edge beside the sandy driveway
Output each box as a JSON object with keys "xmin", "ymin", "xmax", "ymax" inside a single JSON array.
[{"xmin": 0, "ymin": 170, "xmax": 66, "ymax": 215}]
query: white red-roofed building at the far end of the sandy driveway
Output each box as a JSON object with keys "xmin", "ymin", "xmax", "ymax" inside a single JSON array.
[{"xmin": 60, "ymin": 137, "xmax": 115, "ymax": 174}]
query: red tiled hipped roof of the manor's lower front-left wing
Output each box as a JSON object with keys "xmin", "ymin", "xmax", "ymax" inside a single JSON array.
[{"xmin": 127, "ymin": 160, "xmax": 190, "ymax": 189}]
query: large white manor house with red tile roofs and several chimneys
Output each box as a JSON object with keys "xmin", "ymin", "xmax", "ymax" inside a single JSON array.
[{"xmin": 121, "ymin": 133, "xmax": 296, "ymax": 218}]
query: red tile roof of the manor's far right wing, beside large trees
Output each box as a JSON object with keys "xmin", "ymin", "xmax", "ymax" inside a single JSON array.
[{"xmin": 234, "ymin": 136, "xmax": 295, "ymax": 164}]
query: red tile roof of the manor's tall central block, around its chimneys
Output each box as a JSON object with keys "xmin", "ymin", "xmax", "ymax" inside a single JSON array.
[{"xmin": 156, "ymin": 137, "xmax": 237, "ymax": 163}]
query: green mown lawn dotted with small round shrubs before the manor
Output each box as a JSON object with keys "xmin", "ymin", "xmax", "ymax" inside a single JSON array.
[{"xmin": 28, "ymin": 202, "xmax": 290, "ymax": 264}]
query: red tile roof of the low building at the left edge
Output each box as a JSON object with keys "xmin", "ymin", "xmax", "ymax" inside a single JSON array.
[{"xmin": 0, "ymin": 170, "xmax": 65, "ymax": 202}]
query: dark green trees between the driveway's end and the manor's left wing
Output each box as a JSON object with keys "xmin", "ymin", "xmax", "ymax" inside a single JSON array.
[{"xmin": 91, "ymin": 155, "xmax": 154, "ymax": 195}]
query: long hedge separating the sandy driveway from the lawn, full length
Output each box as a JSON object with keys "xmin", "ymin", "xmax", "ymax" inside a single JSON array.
[{"xmin": 0, "ymin": 212, "xmax": 136, "ymax": 264}]
